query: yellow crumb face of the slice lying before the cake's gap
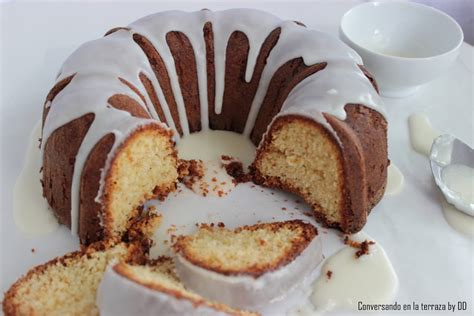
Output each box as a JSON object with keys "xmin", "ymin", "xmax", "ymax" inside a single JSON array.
[{"xmin": 173, "ymin": 221, "xmax": 317, "ymax": 277}]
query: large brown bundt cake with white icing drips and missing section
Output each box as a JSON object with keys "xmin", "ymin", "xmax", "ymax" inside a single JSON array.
[{"xmin": 41, "ymin": 9, "xmax": 388, "ymax": 244}]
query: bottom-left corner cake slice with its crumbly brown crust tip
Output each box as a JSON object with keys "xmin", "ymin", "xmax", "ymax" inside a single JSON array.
[{"xmin": 3, "ymin": 211, "xmax": 161, "ymax": 316}]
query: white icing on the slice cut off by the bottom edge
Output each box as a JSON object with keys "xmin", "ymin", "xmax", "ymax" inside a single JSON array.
[{"xmin": 97, "ymin": 266, "xmax": 227, "ymax": 316}]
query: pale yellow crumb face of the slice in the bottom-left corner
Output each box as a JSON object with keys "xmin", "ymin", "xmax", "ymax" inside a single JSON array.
[{"xmin": 4, "ymin": 243, "xmax": 141, "ymax": 315}]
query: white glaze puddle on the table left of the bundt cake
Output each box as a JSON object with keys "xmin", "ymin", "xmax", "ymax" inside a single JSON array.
[{"xmin": 13, "ymin": 122, "xmax": 59, "ymax": 235}]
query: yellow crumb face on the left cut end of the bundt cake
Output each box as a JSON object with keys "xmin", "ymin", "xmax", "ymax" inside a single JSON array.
[{"xmin": 104, "ymin": 127, "xmax": 178, "ymax": 236}]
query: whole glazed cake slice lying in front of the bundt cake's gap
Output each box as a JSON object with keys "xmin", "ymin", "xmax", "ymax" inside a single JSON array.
[{"xmin": 173, "ymin": 220, "xmax": 322, "ymax": 310}]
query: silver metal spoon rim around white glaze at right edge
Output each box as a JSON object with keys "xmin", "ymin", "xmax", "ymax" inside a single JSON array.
[{"xmin": 430, "ymin": 134, "xmax": 474, "ymax": 216}]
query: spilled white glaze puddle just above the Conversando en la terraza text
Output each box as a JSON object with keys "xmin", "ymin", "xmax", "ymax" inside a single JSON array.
[{"xmin": 312, "ymin": 232, "xmax": 398, "ymax": 312}]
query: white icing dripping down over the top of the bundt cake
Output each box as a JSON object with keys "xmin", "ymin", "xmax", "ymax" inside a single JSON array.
[{"xmin": 42, "ymin": 9, "xmax": 383, "ymax": 233}]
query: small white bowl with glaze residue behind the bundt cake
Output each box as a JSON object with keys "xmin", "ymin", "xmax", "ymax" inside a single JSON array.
[{"xmin": 340, "ymin": 2, "xmax": 464, "ymax": 97}]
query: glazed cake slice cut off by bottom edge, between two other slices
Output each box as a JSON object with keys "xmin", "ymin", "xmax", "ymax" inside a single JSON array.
[{"xmin": 97, "ymin": 257, "xmax": 258, "ymax": 316}]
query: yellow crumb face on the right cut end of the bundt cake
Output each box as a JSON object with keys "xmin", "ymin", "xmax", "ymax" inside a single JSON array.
[{"xmin": 254, "ymin": 116, "xmax": 344, "ymax": 223}]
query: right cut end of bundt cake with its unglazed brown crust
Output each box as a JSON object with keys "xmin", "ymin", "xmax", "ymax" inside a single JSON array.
[{"xmin": 254, "ymin": 104, "xmax": 389, "ymax": 233}]
